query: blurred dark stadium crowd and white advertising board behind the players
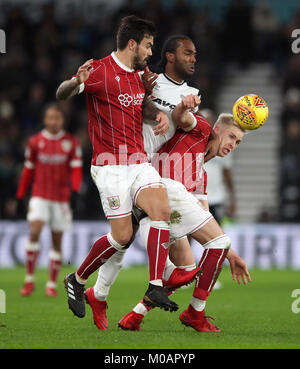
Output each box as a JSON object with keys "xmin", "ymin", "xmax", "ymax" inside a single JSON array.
[{"xmin": 0, "ymin": 0, "xmax": 300, "ymax": 269}]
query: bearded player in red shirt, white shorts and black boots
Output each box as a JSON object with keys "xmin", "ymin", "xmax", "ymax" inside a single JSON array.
[{"xmin": 57, "ymin": 16, "xmax": 193, "ymax": 317}]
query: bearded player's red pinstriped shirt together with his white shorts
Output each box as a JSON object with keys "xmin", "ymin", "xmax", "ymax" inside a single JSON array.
[{"xmin": 79, "ymin": 53, "xmax": 161, "ymax": 219}]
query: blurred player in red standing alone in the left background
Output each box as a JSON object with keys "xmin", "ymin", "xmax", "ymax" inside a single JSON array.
[{"xmin": 17, "ymin": 103, "xmax": 82, "ymax": 297}]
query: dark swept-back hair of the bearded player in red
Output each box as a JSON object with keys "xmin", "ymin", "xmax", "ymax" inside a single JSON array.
[{"xmin": 117, "ymin": 15, "xmax": 156, "ymax": 50}]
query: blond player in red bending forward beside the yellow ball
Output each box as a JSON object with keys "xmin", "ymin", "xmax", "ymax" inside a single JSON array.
[{"xmin": 119, "ymin": 96, "xmax": 251, "ymax": 332}]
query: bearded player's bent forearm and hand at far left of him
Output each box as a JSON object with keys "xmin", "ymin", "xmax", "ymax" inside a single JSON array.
[{"xmin": 56, "ymin": 59, "xmax": 93, "ymax": 100}]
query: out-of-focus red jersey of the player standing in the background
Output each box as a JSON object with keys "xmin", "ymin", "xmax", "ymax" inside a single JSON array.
[{"xmin": 24, "ymin": 130, "xmax": 82, "ymax": 202}]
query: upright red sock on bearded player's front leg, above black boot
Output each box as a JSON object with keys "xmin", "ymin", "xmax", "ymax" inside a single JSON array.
[{"xmin": 147, "ymin": 221, "xmax": 170, "ymax": 286}]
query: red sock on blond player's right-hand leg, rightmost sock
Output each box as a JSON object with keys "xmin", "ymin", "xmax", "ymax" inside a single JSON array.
[{"xmin": 193, "ymin": 248, "xmax": 228, "ymax": 301}]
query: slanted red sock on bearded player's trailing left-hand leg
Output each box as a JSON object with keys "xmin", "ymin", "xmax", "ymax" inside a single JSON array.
[{"xmin": 77, "ymin": 233, "xmax": 122, "ymax": 281}]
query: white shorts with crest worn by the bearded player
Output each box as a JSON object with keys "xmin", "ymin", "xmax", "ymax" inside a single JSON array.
[{"xmin": 91, "ymin": 163, "xmax": 162, "ymax": 219}]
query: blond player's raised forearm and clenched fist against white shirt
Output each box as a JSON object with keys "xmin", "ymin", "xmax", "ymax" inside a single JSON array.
[{"xmin": 172, "ymin": 94, "xmax": 201, "ymax": 130}]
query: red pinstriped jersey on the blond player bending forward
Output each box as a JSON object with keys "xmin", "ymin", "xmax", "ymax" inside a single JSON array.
[{"xmin": 152, "ymin": 115, "xmax": 211, "ymax": 195}]
